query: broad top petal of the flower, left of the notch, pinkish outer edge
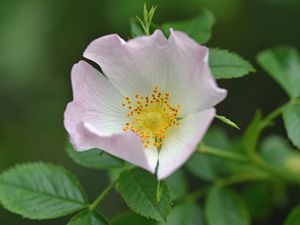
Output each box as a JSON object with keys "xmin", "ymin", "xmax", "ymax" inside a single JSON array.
[{"xmin": 83, "ymin": 30, "xmax": 168, "ymax": 97}]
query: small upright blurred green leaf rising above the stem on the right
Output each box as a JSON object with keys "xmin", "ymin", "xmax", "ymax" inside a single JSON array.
[{"xmin": 242, "ymin": 111, "xmax": 269, "ymax": 155}]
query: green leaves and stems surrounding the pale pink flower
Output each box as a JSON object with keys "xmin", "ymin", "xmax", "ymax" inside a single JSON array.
[{"xmin": 0, "ymin": 5, "xmax": 300, "ymax": 225}]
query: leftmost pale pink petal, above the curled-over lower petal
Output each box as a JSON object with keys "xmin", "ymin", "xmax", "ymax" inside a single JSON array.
[{"xmin": 65, "ymin": 61, "xmax": 126, "ymax": 136}]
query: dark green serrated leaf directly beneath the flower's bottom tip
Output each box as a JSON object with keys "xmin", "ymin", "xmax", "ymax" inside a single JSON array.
[{"xmin": 117, "ymin": 169, "xmax": 171, "ymax": 222}]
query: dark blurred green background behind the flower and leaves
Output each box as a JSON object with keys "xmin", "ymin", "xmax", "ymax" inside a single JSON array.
[{"xmin": 0, "ymin": 0, "xmax": 300, "ymax": 225}]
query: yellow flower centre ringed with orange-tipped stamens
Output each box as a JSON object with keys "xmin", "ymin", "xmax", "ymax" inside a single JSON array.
[{"xmin": 122, "ymin": 86, "xmax": 180, "ymax": 148}]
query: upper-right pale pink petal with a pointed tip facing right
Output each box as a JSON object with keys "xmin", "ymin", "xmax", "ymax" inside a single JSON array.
[{"xmin": 169, "ymin": 30, "xmax": 227, "ymax": 113}]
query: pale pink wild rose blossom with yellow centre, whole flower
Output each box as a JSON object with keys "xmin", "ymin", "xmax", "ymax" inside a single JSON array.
[{"xmin": 64, "ymin": 30, "xmax": 226, "ymax": 179}]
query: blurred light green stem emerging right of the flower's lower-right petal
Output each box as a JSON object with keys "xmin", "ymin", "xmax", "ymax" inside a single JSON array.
[{"xmin": 197, "ymin": 144, "xmax": 249, "ymax": 162}]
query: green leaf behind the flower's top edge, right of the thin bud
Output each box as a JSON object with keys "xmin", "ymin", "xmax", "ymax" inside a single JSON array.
[{"xmin": 162, "ymin": 9, "xmax": 215, "ymax": 44}]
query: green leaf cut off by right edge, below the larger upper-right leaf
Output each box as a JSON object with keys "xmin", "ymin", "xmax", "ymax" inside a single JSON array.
[{"xmin": 283, "ymin": 104, "xmax": 300, "ymax": 148}]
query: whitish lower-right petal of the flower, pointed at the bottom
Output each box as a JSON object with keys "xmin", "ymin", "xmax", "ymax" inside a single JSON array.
[{"xmin": 157, "ymin": 108, "xmax": 215, "ymax": 179}]
